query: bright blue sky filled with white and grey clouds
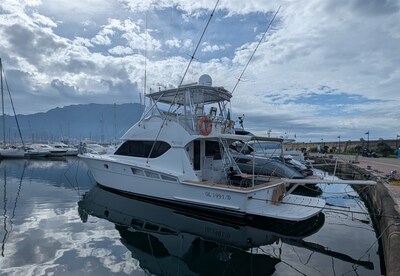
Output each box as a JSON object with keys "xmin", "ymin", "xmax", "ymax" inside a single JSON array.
[{"xmin": 0, "ymin": 0, "xmax": 400, "ymax": 141}]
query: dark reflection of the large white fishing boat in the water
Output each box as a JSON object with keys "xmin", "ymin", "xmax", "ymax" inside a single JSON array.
[{"xmin": 78, "ymin": 186, "xmax": 325, "ymax": 275}]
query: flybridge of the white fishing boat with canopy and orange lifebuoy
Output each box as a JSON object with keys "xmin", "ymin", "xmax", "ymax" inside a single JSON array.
[{"xmin": 142, "ymin": 75, "xmax": 234, "ymax": 136}]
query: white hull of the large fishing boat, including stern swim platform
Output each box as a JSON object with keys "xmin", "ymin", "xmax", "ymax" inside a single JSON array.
[{"xmin": 80, "ymin": 155, "xmax": 325, "ymax": 221}]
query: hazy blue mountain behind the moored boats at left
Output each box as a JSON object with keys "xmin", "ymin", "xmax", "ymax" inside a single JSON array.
[{"xmin": 0, "ymin": 103, "xmax": 144, "ymax": 143}]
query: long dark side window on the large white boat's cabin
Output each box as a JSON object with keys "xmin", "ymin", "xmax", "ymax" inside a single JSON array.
[{"xmin": 115, "ymin": 141, "xmax": 171, "ymax": 158}]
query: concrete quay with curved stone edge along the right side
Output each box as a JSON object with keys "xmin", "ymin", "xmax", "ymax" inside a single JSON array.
[{"xmin": 311, "ymin": 155, "xmax": 400, "ymax": 276}]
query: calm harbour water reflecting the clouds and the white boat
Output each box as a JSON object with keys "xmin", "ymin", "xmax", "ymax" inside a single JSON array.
[{"xmin": 0, "ymin": 158, "xmax": 381, "ymax": 275}]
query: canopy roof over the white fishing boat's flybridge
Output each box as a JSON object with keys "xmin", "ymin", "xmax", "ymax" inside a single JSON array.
[{"xmin": 146, "ymin": 75, "xmax": 232, "ymax": 105}]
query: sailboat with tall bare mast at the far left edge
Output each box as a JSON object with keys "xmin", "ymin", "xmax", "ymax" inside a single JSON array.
[{"xmin": 0, "ymin": 58, "xmax": 25, "ymax": 158}]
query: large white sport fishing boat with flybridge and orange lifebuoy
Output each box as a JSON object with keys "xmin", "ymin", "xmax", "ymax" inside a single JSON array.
[{"xmin": 79, "ymin": 75, "xmax": 325, "ymax": 221}]
